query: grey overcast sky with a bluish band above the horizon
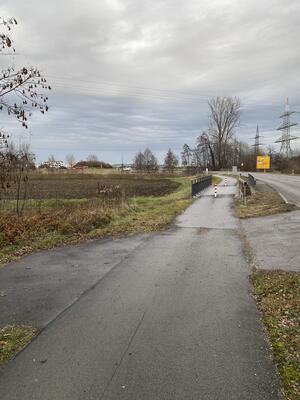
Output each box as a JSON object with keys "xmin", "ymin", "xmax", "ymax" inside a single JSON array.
[{"xmin": 0, "ymin": 0, "xmax": 300, "ymax": 163}]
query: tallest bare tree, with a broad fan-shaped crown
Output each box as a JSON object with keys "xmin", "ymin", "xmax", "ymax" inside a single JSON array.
[{"xmin": 208, "ymin": 96, "xmax": 241, "ymax": 169}]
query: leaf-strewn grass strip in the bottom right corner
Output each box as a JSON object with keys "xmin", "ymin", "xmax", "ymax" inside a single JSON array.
[{"xmin": 252, "ymin": 271, "xmax": 300, "ymax": 400}]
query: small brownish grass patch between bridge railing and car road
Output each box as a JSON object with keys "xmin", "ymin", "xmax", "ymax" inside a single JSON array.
[{"xmin": 235, "ymin": 192, "xmax": 298, "ymax": 218}]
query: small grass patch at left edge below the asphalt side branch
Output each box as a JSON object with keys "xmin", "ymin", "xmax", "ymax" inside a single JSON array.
[{"xmin": 0, "ymin": 325, "xmax": 38, "ymax": 366}]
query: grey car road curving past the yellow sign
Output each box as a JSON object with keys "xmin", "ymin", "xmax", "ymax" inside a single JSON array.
[{"xmin": 252, "ymin": 173, "xmax": 300, "ymax": 207}]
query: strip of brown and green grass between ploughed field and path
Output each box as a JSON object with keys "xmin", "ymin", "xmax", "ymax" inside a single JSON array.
[{"xmin": 0, "ymin": 177, "xmax": 191, "ymax": 264}]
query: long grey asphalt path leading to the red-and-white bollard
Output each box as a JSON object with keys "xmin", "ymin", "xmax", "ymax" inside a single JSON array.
[{"xmin": 0, "ymin": 179, "xmax": 280, "ymax": 400}]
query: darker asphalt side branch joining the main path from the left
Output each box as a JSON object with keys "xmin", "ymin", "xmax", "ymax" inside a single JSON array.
[{"xmin": 0, "ymin": 234, "xmax": 149, "ymax": 328}]
